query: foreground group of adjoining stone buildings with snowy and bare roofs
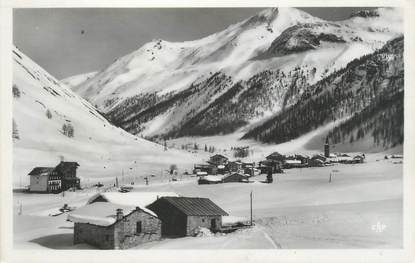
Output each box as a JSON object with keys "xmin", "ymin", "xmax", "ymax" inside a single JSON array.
[{"xmin": 68, "ymin": 192, "xmax": 247, "ymax": 249}]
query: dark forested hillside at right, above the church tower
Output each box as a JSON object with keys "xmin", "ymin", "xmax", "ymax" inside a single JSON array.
[{"xmin": 243, "ymin": 37, "xmax": 404, "ymax": 151}]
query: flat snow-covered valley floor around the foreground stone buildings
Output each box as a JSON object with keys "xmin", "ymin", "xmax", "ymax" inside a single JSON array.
[{"xmin": 13, "ymin": 154, "xmax": 403, "ymax": 249}]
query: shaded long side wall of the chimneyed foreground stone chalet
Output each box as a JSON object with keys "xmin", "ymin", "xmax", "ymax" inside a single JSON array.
[{"xmin": 74, "ymin": 223, "xmax": 114, "ymax": 249}]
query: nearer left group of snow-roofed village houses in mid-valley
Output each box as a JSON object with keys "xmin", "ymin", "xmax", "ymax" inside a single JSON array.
[{"xmin": 193, "ymin": 154, "xmax": 260, "ymax": 184}]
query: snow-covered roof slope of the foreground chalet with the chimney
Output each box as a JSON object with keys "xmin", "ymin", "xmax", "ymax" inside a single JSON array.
[{"xmin": 68, "ymin": 202, "xmax": 136, "ymax": 226}]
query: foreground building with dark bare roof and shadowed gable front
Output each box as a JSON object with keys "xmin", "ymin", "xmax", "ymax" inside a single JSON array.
[{"xmin": 147, "ymin": 197, "xmax": 228, "ymax": 236}]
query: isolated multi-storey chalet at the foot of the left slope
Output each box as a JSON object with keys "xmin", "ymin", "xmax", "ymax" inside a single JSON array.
[{"xmin": 29, "ymin": 161, "xmax": 80, "ymax": 193}]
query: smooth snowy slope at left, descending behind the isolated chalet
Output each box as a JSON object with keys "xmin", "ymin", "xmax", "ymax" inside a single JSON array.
[{"xmin": 12, "ymin": 47, "xmax": 195, "ymax": 188}]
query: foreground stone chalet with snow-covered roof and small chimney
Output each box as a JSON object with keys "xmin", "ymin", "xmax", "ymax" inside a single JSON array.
[{"xmin": 68, "ymin": 202, "xmax": 161, "ymax": 249}]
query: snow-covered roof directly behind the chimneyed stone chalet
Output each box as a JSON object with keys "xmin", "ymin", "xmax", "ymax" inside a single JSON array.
[{"xmin": 87, "ymin": 192, "xmax": 179, "ymax": 216}]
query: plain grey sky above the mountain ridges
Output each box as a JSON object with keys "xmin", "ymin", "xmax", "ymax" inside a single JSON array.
[{"xmin": 13, "ymin": 7, "xmax": 371, "ymax": 79}]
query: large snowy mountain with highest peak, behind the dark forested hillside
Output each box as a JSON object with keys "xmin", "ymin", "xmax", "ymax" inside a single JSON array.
[{"xmin": 69, "ymin": 8, "xmax": 403, "ymax": 140}]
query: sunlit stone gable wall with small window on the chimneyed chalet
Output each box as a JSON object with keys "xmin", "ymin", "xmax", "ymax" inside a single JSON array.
[{"xmin": 114, "ymin": 210, "xmax": 161, "ymax": 249}]
